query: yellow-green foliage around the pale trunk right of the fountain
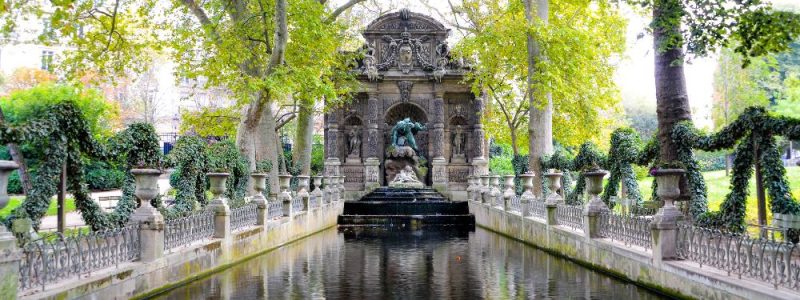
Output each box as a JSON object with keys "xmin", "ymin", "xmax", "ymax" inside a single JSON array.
[{"xmin": 454, "ymin": 0, "xmax": 626, "ymax": 146}]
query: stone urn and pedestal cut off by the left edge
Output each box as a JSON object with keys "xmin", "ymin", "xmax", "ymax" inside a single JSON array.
[{"xmin": 0, "ymin": 160, "xmax": 20, "ymax": 299}]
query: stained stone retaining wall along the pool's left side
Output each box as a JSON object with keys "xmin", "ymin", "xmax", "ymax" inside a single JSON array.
[{"xmin": 20, "ymin": 201, "xmax": 344, "ymax": 299}]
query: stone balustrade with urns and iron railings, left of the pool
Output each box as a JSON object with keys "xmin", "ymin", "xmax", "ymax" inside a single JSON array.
[{"xmin": 0, "ymin": 166, "xmax": 344, "ymax": 299}]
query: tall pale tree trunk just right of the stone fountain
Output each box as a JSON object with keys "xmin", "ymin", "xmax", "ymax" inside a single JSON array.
[{"xmin": 525, "ymin": 0, "xmax": 553, "ymax": 197}]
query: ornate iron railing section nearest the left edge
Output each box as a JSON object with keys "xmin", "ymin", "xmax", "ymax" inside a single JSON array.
[{"xmin": 19, "ymin": 225, "xmax": 141, "ymax": 290}]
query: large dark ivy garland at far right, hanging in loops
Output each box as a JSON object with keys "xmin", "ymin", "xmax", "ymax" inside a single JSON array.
[{"xmin": 672, "ymin": 107, "xmax": 800, "ymax": 232}]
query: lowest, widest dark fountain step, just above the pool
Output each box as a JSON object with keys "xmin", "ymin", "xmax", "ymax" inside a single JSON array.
[{"xmin": 338, "ymin": 215, "xmax": 475, "ymax": 228}]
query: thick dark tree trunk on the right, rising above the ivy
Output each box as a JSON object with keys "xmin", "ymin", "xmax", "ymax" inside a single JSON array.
[{"xmin": 653, "ymin": 0, "xmax": 692, "ymax": 162}]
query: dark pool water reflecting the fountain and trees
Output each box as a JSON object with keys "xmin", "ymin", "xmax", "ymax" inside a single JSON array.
[{"xmin": 153, "ymin": 228, "xmax": 660, "ymax": 299}]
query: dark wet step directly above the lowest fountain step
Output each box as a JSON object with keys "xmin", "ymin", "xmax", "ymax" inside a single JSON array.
[{"xmin": 342, "ymin": 201, "xmax": 469, "ymax": 216}]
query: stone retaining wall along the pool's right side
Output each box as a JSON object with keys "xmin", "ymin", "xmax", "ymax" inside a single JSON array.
[{"xmin": 469, "ymin": 201, "xmax": 800, "ymax": 299}]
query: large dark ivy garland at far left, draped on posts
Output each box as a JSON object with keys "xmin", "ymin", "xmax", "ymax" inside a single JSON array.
[{"xmin": 0, "ymin": 102, "xmax": 161, "ymax": 230}]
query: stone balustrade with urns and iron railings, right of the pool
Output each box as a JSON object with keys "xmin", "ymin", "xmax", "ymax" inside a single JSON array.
[{"xmin": 467, "ymin": 169, "xmax": 800, "ymax": 298}]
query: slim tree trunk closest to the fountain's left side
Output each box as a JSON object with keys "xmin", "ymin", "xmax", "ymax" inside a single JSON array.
[{"xmin": 292, "ymin": 99, "xmax": 314, "ymax": 175}]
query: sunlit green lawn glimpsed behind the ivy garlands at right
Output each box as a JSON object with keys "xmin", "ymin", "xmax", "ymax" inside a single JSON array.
[{"xmin": 638, "ymin": 167, "xmax": 800, "ymax": 224}]
